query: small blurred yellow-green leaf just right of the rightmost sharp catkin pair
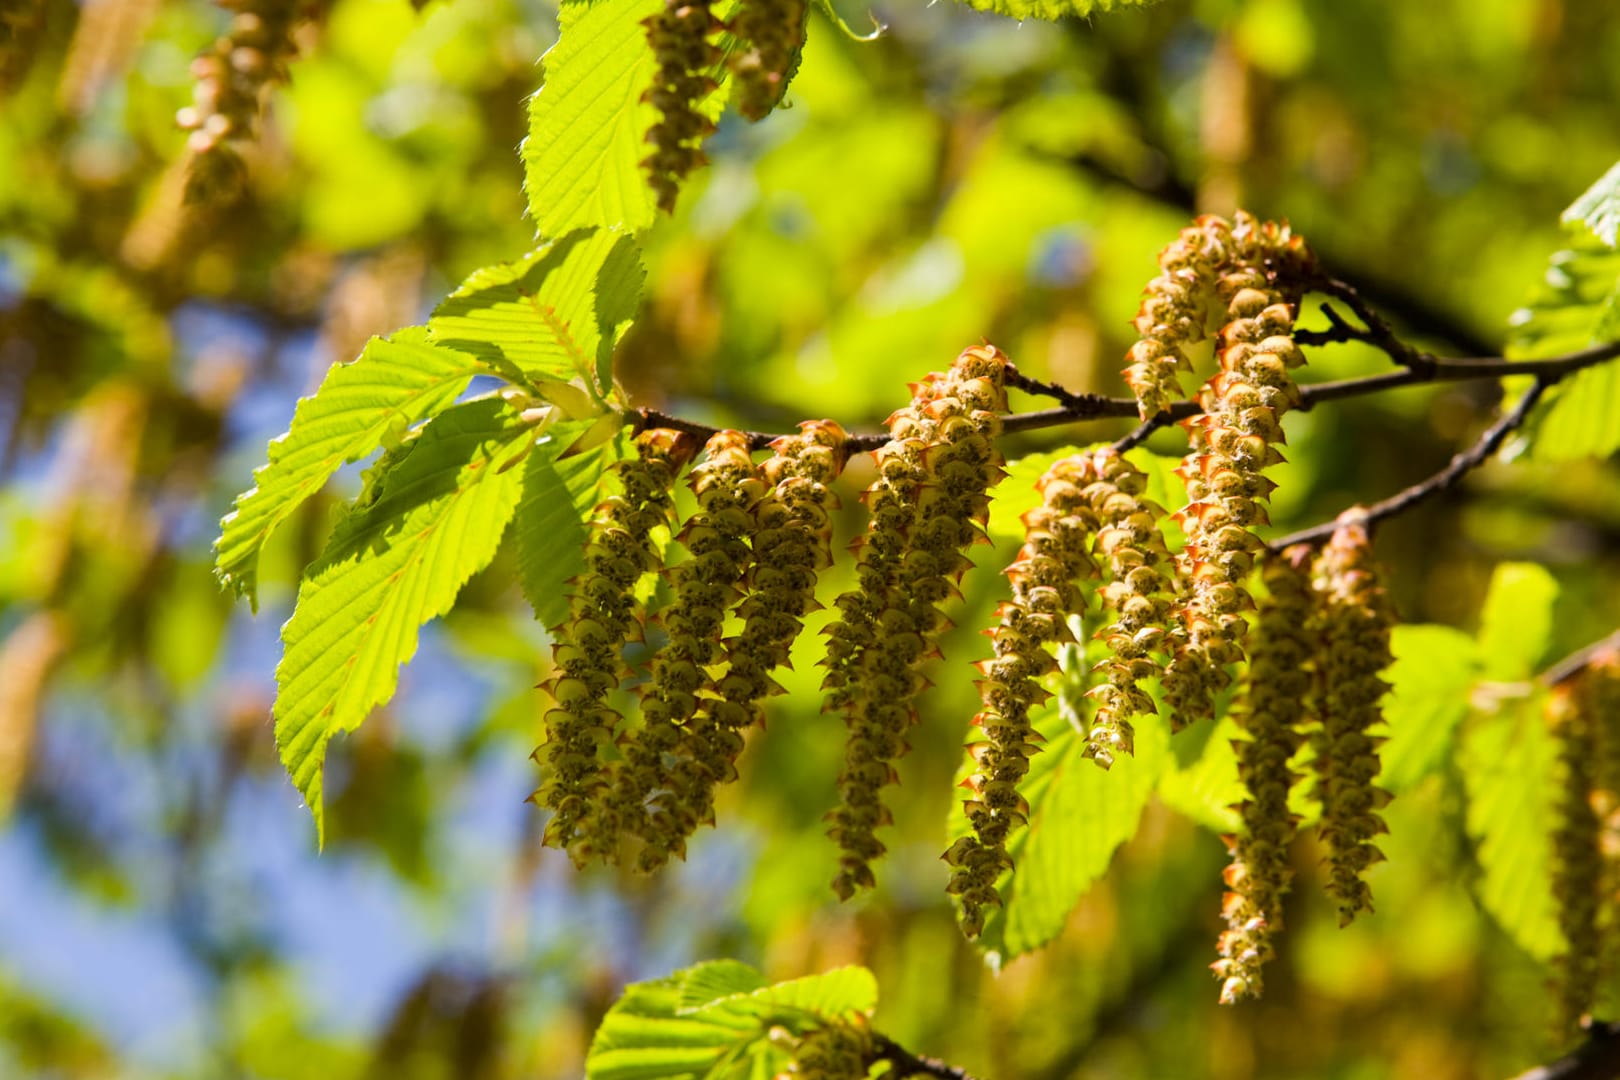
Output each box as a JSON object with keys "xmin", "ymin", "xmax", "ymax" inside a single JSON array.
[{"xmin": 1379, "ymin": 625, "xmax": 1479, "ymax": 795}]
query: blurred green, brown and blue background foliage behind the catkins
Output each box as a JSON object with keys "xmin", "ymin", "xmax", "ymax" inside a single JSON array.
[{"xmin": 0, "ymin": 0, "xmax": 1620, "ymax": 1080}]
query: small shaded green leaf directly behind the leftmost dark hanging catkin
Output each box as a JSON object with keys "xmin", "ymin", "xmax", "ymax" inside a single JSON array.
[{"xmin": 510, "ymin": 421, "xmax": 630, "ymax": 627}]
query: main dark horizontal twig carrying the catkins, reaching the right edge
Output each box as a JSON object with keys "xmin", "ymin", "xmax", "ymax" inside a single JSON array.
[{"xmin": 640, "ymin": 342, "xmax": 1620, "ymax": 452}]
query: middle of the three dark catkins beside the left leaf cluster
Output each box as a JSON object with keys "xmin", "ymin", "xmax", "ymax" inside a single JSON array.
[{"xmin": 625, "ymin": 431, "xmax": 765, "ymax": 871}]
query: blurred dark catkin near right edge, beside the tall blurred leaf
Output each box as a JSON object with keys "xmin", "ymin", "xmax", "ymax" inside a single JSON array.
[{"xmin": 1545, "ymin": 672, "xmax": 1604, "ymax": 1035}]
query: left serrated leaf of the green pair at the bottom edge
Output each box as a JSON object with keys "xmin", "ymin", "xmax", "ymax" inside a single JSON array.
[{"xmin": 585, "ymin": 972, "xmax": 787, "ymax": 1080}]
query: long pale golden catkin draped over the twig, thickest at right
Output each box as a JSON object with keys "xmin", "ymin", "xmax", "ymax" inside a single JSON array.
[{"xmin": 1163, "ymin": 212, "xmax": 1314, "ymax": 729}]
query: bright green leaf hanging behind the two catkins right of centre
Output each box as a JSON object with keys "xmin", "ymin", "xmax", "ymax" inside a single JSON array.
[{"xmin": 953, "ymin": 650, "xmax": 1170, "ymax": 962}]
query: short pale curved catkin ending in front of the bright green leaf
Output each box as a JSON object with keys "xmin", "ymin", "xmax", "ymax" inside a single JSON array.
[{"xmin": 1085, "ymin": 449, "xmax": 1175, "ymax": 769}]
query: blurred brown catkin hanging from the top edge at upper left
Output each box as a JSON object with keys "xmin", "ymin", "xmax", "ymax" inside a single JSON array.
[{"xmin": 175, "ymin": 0, "xmax": 308, "ymax": 199}]
